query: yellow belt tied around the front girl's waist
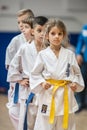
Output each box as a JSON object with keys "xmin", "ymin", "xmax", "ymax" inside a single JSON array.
[{"xmin": 46, "ymin": 79, "xmax": 70, "ymax": 129}]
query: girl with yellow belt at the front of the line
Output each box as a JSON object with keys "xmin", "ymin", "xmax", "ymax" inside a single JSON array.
[{"xmin": 30, "ymin": 19, "xmax": 84, "ymax": 130}]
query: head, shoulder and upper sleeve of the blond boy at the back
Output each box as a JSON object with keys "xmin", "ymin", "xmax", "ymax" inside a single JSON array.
[{"xmin": 5, "ymin": 9, "xmax": 34, "ymax": 69}]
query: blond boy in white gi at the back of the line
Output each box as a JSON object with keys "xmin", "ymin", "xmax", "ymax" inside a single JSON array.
[{"xmin": 5, "ymin": 9, "xmax": 34, "ymax": 130}]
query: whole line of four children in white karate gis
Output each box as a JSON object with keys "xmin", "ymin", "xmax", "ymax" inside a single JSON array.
[{"xmin": 6, "ymin": 9, "xmax": 84, "ymax": 130}]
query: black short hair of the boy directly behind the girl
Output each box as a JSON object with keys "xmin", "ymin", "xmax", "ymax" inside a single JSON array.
[{"xmin": 33, "ymin": 16, "xmax": 48, "ymax": 28}]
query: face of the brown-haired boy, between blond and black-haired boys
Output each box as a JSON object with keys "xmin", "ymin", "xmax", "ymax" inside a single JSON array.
[{"xmin": 22, "ymin": 23, "xmax": 32, "ymax": 41}]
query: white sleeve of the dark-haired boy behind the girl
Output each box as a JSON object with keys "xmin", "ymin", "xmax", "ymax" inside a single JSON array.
[{"xmin": 7, "ymin": 45, "xmax": 23, "ymax": 82}]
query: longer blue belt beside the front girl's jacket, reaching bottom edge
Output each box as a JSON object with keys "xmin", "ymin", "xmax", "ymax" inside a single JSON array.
[{"xmin": 23, "ymin": 92, "xmax": 35, "ymax": 130}]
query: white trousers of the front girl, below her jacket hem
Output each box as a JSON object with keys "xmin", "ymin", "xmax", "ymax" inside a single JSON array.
[{"xmin": 34, "ymin": 110, "xmax": 76, "ymax": 130}]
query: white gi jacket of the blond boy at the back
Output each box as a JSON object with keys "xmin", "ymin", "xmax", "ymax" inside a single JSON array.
[{"xmin": 5, "ymin": 33, "xmax": 26, "ymax": 108}]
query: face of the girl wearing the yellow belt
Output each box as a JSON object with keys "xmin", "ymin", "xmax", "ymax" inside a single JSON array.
[{"xmin": 48, "ymin": 26, "xmax": 64, "ymax": 46}]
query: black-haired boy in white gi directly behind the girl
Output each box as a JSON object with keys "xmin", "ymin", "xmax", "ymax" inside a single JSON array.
[{"xmin": 7, "ymin": 16, "xmax": 48, "ymax": 130}]
